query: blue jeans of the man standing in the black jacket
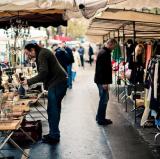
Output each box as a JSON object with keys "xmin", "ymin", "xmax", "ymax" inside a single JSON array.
[{"xmin": 96, "ymin": 84, "xmax": 109, "ymax": 122}]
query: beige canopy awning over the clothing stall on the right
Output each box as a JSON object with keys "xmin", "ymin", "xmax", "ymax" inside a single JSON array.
[{"xmin": 87, "ymin": 8, "xmax": 160, "ymax": 41}]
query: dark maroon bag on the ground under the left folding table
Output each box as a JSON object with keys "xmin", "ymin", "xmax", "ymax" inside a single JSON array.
[{"xmin": 11, "ymin": 119, "xmax": 42, "ymax": 143}]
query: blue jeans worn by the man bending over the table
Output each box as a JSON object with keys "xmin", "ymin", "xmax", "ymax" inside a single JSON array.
[{"xmin": 47, "ymin": 82, "xmax": 67, "ymax": 139}]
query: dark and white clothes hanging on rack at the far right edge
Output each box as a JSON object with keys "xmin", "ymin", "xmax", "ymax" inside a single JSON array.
[{"xmin": 145, "ymin": 55, "xmax": 160, "ymax": 141}]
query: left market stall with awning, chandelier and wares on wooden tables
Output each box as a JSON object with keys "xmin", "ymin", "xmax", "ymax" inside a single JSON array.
[{"xmin": 0, "ymin": 0, "xmax": 130, "ymax": 157}]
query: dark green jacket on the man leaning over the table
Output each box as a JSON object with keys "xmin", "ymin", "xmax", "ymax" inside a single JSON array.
[{"xmin": 27, "ymin": 48, "xmax": 67, "ymax": 89}]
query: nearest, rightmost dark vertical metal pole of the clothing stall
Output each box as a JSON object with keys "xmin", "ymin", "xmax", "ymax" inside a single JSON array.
[{"xmin": 133, "ymin": 22, "xmax": 137, "ymax": 123}]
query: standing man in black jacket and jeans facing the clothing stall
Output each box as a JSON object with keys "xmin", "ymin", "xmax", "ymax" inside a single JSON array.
[{"xmin": 94, "ymin": 39, "xmax": 117, "ymax": 125}]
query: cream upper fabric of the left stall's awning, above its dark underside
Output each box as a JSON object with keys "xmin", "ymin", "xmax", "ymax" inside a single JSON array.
[{"xmin": 0, "ymin": 0, "xmax": 124, "ymax": 18}]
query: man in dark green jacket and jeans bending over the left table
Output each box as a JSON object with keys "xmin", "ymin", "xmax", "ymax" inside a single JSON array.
[{"xmin": 23, "ymin": 44, "xmax": 67, "ymax": 144}]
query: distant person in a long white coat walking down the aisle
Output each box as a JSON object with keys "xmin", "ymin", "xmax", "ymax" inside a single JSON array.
[{"xmin": 72, "ymin": 48, "xmax": 80, "ymax": 81}]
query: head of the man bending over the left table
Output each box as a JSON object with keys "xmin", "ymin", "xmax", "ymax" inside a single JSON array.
[{"xmin": 24, "ymin": 44, "xmax": 40, "ymax": 60}]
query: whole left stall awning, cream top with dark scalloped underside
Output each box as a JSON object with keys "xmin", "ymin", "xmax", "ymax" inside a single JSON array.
[{"xmin": 0, "ymin": 0, "xmax": 123, "ymax": 28}]
